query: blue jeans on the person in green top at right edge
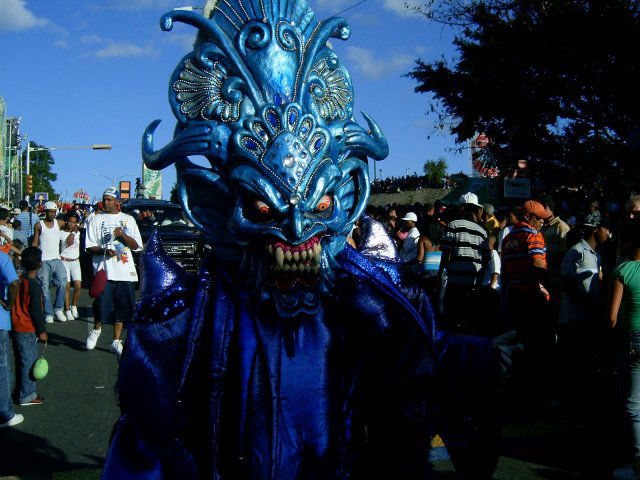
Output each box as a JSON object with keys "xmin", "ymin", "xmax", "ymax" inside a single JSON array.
[{"xmin": 624, "ymin": 332, "xmax": 640, "ymax": 458}]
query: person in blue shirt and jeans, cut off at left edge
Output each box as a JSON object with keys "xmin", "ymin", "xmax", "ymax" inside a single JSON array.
[{"xmin": 0, "ymin": 253, "xmax": 19, "ymax": 427}]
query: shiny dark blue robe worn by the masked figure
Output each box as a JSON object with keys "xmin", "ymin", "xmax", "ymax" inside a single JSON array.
[{"xmin": 103, "ymin": 248, "xmax": 491, "ymax": 480}]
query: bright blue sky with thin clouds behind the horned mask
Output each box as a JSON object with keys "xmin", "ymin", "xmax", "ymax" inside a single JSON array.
[{"xmin": 0, "ymin": 0, "xmax": 468, "ymax": 201}]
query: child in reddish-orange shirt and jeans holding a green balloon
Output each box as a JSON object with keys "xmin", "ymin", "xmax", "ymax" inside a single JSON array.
[{"xmin": 11, "ymin": 247, "xmax": 49, "ymax": 407}]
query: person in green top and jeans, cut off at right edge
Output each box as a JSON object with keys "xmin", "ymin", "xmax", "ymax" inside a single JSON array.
[{"xmin": 609, "ymin": 218, "xmax": 640, "ymax": 475}]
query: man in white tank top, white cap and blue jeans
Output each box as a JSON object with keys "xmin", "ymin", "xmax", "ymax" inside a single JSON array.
[{"xmin": 33, "ymin": 202, "xmax": 67, "ymax": 323}]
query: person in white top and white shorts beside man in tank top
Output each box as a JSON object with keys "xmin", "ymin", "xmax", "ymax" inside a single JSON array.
[{"xmin": 60, "ymin": 210, "xmax": 82, "ymax": 320}]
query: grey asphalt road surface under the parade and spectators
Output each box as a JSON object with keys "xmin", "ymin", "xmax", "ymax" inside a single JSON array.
[{"xmin": 0, "ymin": 291, "xmax": 632, "ymax": 480}]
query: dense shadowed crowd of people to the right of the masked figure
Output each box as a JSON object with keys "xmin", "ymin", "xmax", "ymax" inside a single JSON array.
[{"xmin": 353, "ymin": 193, "xmax": 640, "ymax": 472}]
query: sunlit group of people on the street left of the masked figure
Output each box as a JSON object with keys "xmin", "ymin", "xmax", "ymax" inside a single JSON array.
[{"xmin": 0, "ymin": 187, "xmax": 142, "ymax": 427}]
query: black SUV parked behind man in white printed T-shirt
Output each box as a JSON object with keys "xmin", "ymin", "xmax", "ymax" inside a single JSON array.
[{"xmin": 121, "ymin": 198, "xmax": 203, "ymax": 272}]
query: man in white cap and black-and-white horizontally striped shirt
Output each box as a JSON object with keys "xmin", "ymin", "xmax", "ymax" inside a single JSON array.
[{"xmin": 438, "ymin": 193, "xmax": 489, "ymax": 333}]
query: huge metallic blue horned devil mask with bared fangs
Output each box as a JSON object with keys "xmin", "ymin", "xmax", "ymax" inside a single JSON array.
[{"xmin": 142, "ymin": 0, "xmax": 388, "ymax": 314}]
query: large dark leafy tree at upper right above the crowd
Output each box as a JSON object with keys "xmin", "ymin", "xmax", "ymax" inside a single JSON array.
[{"xmin": 408, "ymin": 0, "xmax": 640, "ymax": 188}]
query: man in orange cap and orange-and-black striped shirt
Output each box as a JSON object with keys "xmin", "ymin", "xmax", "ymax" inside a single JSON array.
[{"xmin": 502, "ymin": 200, "xmax": 553, "ymax": 404}]
